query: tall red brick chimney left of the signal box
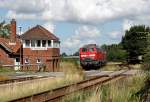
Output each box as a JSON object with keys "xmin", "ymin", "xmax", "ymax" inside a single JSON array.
[{"xmin": 10, "ymin": 19, "xmax": 16, "ymax": 43}]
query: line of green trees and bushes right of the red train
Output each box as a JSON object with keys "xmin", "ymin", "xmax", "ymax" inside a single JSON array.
[{"xmin": 101, "ymin": 25, "xmax": 150, "ymax": 64}]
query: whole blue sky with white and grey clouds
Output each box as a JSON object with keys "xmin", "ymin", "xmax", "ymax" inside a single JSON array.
[{"xmin": 0, "ymin": 0, "xmax": 150, "ymax": 54}]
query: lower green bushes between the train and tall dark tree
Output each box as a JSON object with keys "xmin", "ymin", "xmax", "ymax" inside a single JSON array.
[{"xmin": 101, "ymin": 44, "xmax": 127, "ymax": 61}]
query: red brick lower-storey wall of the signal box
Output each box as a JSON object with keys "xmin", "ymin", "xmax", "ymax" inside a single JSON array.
[{"xmin": 22, "ymin": 48, "xmax": 60, "ymax": 72}]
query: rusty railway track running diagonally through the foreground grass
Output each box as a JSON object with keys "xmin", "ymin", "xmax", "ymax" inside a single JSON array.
[{"xmin": 11, "ymin": 70, "xmax": 127, "ymax": 102}]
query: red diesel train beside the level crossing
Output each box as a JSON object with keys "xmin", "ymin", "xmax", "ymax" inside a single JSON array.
[{"xmin": 79, "ymin": 44, "xmax": 106, "ymax": 69}]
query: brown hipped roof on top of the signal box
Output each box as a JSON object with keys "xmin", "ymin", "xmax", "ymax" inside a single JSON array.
[{"xmin": 21, "ymin": 25, "xmax": 59, "ymax": 41}]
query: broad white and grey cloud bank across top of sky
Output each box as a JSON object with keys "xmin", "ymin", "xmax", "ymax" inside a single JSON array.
[{"xmin": 0, "ymin": 0, "xmax": 150, "ymax": 24}]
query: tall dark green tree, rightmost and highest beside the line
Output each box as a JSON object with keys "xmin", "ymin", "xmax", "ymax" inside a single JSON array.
[{"xmin": 122, "ymin": 25, "xmax": 150, "ymax": 63}]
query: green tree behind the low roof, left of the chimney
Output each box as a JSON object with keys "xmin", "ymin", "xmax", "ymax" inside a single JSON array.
[{"xmin": 0, "ymin": 21, "xmax": 10, "ymax": 38}]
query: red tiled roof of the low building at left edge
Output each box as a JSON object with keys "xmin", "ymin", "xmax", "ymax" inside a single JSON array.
[{"xmin": 0, "ymin": 37, "xmax": 21, "ymax": 53}]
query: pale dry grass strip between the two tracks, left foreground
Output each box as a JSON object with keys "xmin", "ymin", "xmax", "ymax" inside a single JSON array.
[{"xmin": 0, "ymin": 58, "xmax": 84, "ymax": 102}]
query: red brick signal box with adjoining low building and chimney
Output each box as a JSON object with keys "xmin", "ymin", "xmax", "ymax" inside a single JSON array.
[{"xmin": 0, "ymin": 19, "xmax": 60, "ymax": 71}]
